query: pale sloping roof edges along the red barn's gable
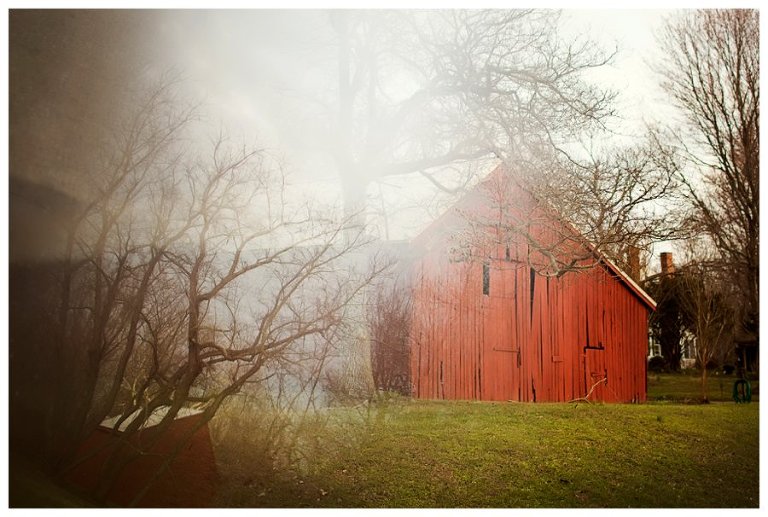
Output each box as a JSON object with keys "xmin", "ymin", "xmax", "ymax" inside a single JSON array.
[{"xmin": 411, "ymin": 164, "xmax": 656, "ymax": 311}]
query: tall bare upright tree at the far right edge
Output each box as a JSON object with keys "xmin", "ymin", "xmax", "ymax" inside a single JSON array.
[{"xmin": 660, "ymin": 9, "xmax": 760, "ymax": 350}]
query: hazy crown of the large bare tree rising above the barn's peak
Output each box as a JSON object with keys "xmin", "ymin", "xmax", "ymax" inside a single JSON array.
[{"xmin": 320, "ymin": 10, "xmax": 613, "ymax": 223}]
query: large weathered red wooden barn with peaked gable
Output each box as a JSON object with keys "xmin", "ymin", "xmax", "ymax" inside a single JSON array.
[{"xmin": 409, "ymin": 168, "xmax": 655, "ymax": 402}]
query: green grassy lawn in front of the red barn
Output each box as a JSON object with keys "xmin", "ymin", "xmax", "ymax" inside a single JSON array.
[{"xmin": 217, "ymin": 376, "xmax": 759, "ymax": 508}]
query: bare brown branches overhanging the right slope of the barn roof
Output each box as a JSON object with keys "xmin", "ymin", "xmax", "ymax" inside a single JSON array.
[{"xmin": 448, "ymin": 134, "xmax": 679, "ymax": 276}]
